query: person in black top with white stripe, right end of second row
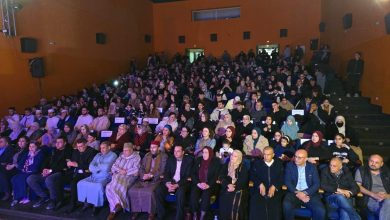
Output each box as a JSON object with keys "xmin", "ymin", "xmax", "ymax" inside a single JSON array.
[{"xmin": 329, "ymin": 133, "xmax": 362, "ymax": 171}]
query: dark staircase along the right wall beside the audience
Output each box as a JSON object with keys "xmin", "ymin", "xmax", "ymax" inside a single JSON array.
[{"xmin": 327, "ymin": 66, "xmax": 390, "ymax": 161}]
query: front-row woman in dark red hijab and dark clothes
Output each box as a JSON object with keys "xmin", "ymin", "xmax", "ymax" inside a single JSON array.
[{"xmin": 190, "ymin": 146, "xmax": 221, "ymax": 220}]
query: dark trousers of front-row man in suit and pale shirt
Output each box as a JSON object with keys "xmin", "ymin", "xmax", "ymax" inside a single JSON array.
[{"xmin": 155, "ymin": 184, "xmax": 188, "ymax": 220}]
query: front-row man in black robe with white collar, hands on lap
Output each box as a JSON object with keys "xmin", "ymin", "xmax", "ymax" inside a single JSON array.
[{"xmin": 249, "ymin": 147, "xmax": 283, "ymax": 220}]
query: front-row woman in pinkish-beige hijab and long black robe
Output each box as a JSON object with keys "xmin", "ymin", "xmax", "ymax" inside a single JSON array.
[{"xmin": 218, "ymin": 150, "xmax": 248, "ymax": 220}]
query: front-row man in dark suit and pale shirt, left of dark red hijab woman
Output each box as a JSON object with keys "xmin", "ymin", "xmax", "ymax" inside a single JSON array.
[{"xmin": 155, "ymin": 146, "xmax": 193, "ymax": 220}]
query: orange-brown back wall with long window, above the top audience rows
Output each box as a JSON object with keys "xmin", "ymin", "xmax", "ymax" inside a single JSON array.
[{"xmin": 153, "ymin": 0, "xmax": 321, "ymax": 56}]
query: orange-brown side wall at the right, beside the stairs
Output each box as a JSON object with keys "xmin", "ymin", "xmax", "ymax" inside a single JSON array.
[{"xmin": 321, "ymin": 0, "xmax": 390, "ymax": 113}]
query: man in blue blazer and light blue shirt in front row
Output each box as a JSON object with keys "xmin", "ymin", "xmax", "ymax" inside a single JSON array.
[{"xmin": 283, "ymin": 150, "xmax": 325, "ymax": 220}]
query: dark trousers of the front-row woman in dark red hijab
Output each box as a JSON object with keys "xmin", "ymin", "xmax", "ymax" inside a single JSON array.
[{"xmin": 190, "ymin": 185, "xmax": 211, "ymax": 213}]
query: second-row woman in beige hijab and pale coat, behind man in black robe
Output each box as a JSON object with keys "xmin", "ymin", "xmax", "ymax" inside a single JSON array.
[{"xmin": 243, "ymin": 127, "xmax": 269, "ymax": 157}]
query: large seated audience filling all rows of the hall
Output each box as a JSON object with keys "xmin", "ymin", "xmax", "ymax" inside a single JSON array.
[{"xmin": 0, "ymin": 48, "xmax": 390, "ymax": 220}]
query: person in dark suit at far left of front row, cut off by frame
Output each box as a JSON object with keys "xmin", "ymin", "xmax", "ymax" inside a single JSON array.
[{"xmin": 0, "ymin": 137, "xmax": 15, "ymax": 201}]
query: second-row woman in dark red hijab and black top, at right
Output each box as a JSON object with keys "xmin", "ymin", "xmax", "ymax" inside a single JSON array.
[{"xmin": 302, "ymin": 131, "xmax": 331, "ymax": 166}]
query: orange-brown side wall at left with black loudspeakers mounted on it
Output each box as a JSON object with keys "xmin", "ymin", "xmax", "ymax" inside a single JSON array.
[{"xmin": 0, "ymin": 0, "xmax": 153, "ymax": 115}]
